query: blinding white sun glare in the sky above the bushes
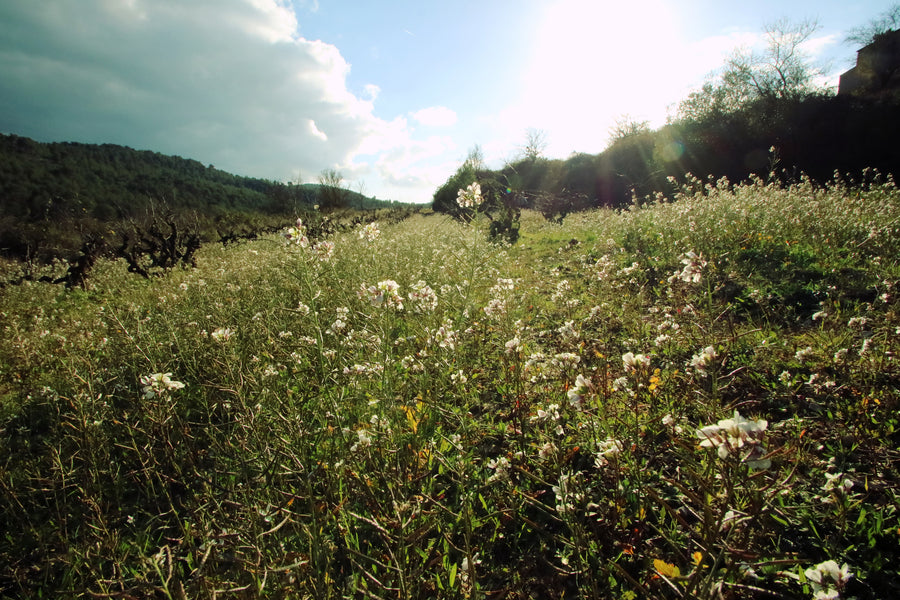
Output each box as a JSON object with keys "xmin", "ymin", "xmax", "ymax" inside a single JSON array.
[{"xmin": 522, "ymin": 0, "xmax": 684, "ymax": 153}]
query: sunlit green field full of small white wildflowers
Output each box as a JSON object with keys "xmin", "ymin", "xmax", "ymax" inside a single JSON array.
[{"xmin": 0, "ymin": 173, "xmax": 900, "ymax": 599}]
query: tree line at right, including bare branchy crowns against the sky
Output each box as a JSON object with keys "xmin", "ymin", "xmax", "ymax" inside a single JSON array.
[{"xmin": 432, "ymin": 12, "xmax": 900, "ymax": 225}]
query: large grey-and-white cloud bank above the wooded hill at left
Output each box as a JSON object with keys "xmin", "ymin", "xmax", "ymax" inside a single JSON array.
[{"xmin": 0, "ymin": 0, "xmax": 444, "ymax": 200}]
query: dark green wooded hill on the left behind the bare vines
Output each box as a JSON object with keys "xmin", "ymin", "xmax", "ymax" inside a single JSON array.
[{"xmin": 0, "ymin": 134, "xmax": 398, "ymax": 260}]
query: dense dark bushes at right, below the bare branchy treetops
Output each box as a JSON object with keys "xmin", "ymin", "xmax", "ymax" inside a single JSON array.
[{"xmin": 433, "ymin": 95, "xmax": 900, "ymax": 221}]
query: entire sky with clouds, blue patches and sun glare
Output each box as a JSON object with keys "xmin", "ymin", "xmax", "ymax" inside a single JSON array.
[{"xmin": 0, "ymin": 0, "xmax": 895, "ymax": 202}]
